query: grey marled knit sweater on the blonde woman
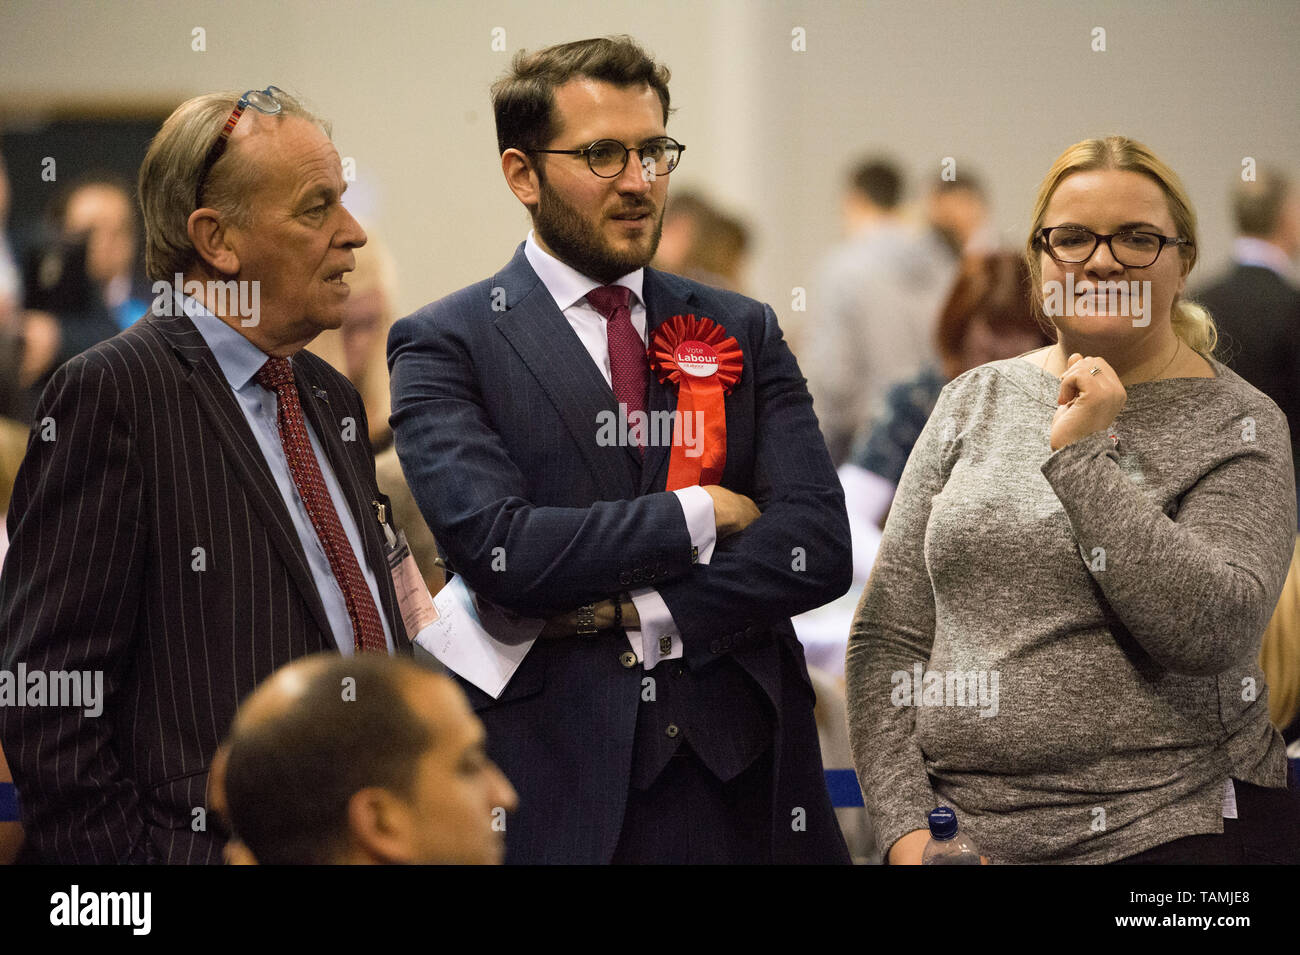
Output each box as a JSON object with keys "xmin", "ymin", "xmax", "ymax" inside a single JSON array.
[{"xmin": 846, "ymin": 357, "xmax": 1296, "ymax": 863}]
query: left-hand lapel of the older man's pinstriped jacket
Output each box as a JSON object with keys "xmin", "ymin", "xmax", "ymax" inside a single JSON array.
[{"xmin": 144, "ymin": 314, "xmax": 334, "ymax": 647}]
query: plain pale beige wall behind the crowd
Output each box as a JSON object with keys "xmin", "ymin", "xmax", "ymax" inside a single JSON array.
[{"xmin": 0, "ymin": 0, "xmax": 1300, "ymax": 353}]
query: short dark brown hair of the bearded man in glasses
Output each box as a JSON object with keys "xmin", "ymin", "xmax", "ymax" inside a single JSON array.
[{"xmin": 491, "ymin": 36, "xmax": 670, "ymax": 152}]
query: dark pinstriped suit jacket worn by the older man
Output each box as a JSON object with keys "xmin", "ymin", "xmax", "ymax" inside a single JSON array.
[{"xmin": 0, "ymin": 307, "xmax": 410, "ymax": 863}]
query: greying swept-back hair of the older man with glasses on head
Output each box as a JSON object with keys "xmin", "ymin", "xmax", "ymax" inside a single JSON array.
[{"xmin": 138, "ymin": 91, "xmax": 330, "ymax": 279}]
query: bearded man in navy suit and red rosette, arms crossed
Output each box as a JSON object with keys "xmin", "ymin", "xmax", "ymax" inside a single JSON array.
[{"xmin": 389, "ymin": 38, "xmax": 850, "ymax": 863}]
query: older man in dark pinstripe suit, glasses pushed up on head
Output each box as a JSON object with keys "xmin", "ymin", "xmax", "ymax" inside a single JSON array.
[{"xmin": 0, "ymin": 87, "xmax": 410, "ymax": 863}]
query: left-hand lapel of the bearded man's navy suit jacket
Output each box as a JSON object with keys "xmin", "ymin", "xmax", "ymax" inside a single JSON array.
[{"xmin": 493, "ymin": 246, "xmax": 640, "ymax": 499}]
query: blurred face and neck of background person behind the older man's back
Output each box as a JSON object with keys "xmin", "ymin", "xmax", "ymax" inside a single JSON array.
[{"xmin": 53, "ymin": 174, "xmax": 153, "ymax": 329}]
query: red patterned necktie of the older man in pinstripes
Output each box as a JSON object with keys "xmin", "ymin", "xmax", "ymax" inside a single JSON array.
[{"xmin": 256, "ymin": 359, "xmax": 389, "ymax": 654}]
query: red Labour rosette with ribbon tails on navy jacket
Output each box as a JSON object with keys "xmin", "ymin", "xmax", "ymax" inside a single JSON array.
[{"xmin": 649, "ymin": 314, "xmax": 745, "ymax": 491}]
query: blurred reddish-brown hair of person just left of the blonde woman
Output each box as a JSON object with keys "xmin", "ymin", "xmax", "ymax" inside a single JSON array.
[{"xmin": 935, "ymin": 252, "xmax": 1056, "ymax": 378}]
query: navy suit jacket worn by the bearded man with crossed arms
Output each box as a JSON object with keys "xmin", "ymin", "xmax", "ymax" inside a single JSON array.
[{"xmin": 389, "ymin": 246, "xmax": 852, "ymax": 863}]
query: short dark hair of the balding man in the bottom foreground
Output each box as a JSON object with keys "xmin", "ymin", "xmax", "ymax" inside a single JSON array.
[{"xmin": 225, "ymin": 654, "xmax": 433, "ymax": 865}]
